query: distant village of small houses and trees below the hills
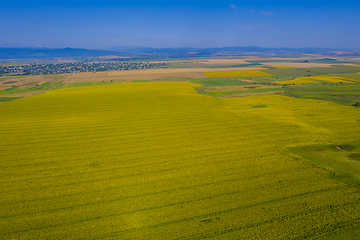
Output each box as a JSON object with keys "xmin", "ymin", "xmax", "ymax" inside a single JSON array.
[{"xmin": 0, "ymin": 62, "xmax": 170, "ymax": 75}]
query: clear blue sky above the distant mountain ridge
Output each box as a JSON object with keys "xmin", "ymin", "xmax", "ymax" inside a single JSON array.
[{"xmin": 0, "ymin": 0, "xmax": 360, "ymax": 50}]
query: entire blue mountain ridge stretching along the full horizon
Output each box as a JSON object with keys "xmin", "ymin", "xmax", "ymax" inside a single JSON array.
[{"xmin": 0, "ymin": 46, "xmax": 360, "ymax": 59}]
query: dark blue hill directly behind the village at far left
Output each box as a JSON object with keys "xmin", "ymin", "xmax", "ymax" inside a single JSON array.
[{"xmin": 0, "ymin": 48, "xmax": 119, "ymax": 59}]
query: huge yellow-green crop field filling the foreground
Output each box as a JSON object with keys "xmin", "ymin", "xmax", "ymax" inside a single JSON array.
[{"xmin": 0, "ymin": 82, "xmax": 360, "ymax": 239}]
